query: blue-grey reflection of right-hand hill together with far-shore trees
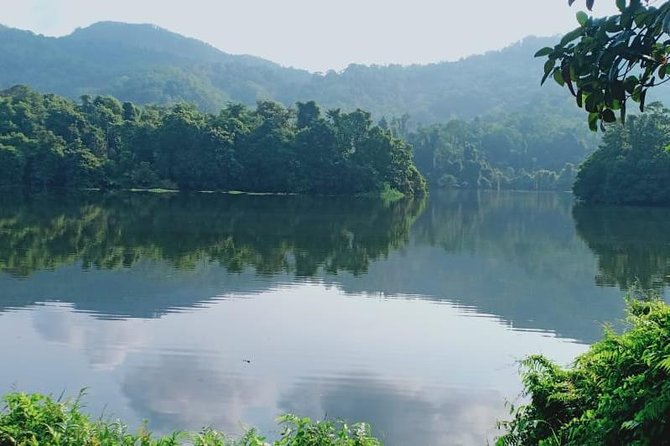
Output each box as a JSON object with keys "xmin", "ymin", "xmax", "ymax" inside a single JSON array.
[{"xmin": 337, "ymin": 192, "xmax": 624, "ymax": 342}]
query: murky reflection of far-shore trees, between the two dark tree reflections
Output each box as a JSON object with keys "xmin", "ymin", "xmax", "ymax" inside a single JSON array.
[{"xmin": 414, "ymin": 192, "xmax": 574, "ymax": 269}]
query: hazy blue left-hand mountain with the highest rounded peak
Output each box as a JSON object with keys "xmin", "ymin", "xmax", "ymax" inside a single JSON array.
[{"xmin": 0, "ymin": 22, "xmax": 311, "ymax": 111}]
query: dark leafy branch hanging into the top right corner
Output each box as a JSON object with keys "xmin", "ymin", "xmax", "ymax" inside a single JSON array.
[{"xmin": 535, "ymin": 0, "xmax": 670, "ymax": 131}]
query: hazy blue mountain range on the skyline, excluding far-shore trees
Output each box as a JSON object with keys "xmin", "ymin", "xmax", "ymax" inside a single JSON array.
[{"xmin": 0, "ymin": 22, "xmax": 600, "ymax": 123}]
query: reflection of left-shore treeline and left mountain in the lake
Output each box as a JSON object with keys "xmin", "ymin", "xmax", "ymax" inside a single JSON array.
[{"xmin": 0, "ymin": 193, "xmax": 423, "ymax": 317}]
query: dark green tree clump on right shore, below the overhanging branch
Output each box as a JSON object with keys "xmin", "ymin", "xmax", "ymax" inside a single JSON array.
[{"xmin": 574, "ymin": 103, "xmax": 670, "ymax": 206}]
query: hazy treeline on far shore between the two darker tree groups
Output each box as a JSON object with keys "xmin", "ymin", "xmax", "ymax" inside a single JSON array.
[{"xmin": 404, "ymin": 110, "xmax": 597, "ymax": 191}]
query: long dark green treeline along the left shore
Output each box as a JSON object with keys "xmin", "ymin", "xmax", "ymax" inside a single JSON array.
[{"xmin": 0, "ymin": 86, "xmax": 426, "ymax": 195}]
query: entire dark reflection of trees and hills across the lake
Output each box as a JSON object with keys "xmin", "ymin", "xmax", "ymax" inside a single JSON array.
[{"xmin": 0, "ymin": 192, "xmax": 670, "ymax": 342}]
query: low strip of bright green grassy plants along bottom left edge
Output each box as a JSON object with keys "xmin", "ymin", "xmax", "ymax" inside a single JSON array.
[{"xmin": 0, "ymin": 392, "xmax": 381, "ymax": 446}]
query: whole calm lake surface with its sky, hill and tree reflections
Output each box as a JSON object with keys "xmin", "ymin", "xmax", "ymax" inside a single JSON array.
[{"xmin": 0, "ymin": 193, "xmax": 670, "ymax": 445}]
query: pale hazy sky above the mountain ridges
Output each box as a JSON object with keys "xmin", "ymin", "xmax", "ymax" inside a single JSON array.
[{"xmin": 0, "ymin": 0, "xmax": 615, "ymax": 71}]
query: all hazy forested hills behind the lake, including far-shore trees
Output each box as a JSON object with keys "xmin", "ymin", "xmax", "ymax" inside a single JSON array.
[{"xmin": 0, "ymin": 22, "xmax": 598, "ymax": 190}]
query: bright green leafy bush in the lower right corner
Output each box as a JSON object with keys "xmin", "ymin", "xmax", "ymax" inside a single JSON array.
[{"xmin": 497, "ymin": 298, "xmax": 670, "ymax": 446}]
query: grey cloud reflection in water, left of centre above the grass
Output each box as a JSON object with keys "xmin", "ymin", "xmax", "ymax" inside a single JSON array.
[{"xmin": 122, "ymin": 355, "xmax": 276, "ymax": 433}]
